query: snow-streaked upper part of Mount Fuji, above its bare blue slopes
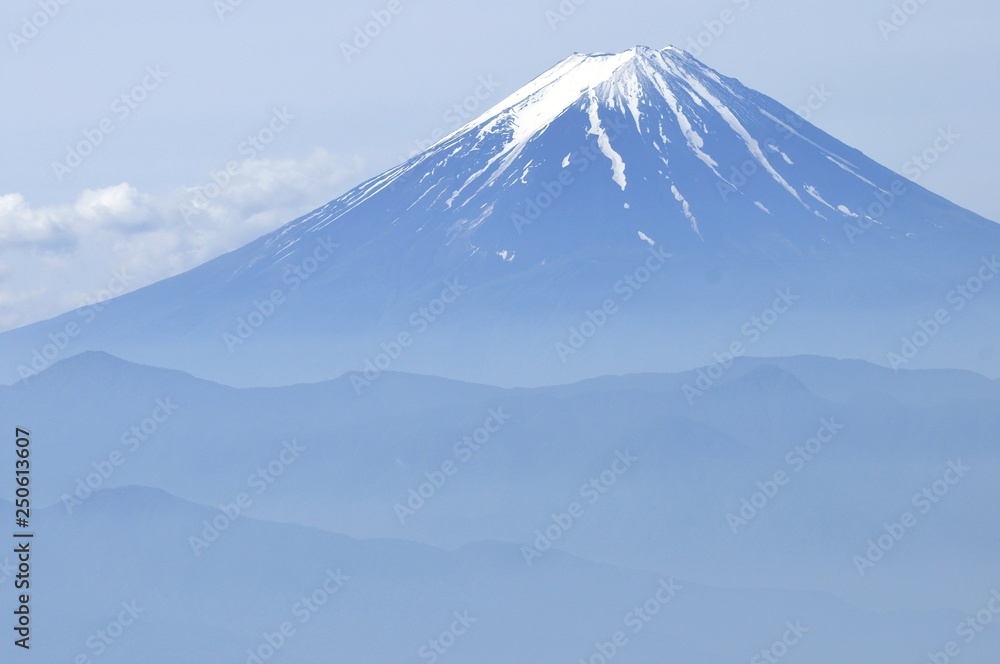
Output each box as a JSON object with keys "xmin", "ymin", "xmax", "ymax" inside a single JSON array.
[{"xmin": 292, "ymin": 46, "xmax": 916, "ymax": 256}]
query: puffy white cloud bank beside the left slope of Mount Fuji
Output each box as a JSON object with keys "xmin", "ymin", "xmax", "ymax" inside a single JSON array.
[{"xmin": 0, "ymin": 150, "xmax": 362, "ymax": 330}]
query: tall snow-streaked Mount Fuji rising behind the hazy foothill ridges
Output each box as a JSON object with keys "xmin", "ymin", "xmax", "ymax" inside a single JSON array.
[{"xmin": 0, "ymin": 47, "xmax": 1000, "ymax": 385}]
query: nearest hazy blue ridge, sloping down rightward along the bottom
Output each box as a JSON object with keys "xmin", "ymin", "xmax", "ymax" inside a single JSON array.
[{"xmin": 0, "ymin": 487, "xmax": 968, "ymax": 664}]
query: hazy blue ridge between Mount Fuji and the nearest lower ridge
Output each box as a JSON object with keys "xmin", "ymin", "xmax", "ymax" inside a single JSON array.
[{"xmin": 9, "ymin": 353, "xmax": 1000, "ymax": 609}]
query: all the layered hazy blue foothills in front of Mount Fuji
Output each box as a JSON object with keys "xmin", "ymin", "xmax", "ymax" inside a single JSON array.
[{"xmin": 0, "ymin": 353, "xmax": 1000, "ymax": 663}]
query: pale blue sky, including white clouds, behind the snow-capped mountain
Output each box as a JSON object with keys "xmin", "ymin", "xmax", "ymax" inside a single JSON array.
[{"xmin": 0, "ymin": 0, "xmax": 1000, "ymax": 328}]
